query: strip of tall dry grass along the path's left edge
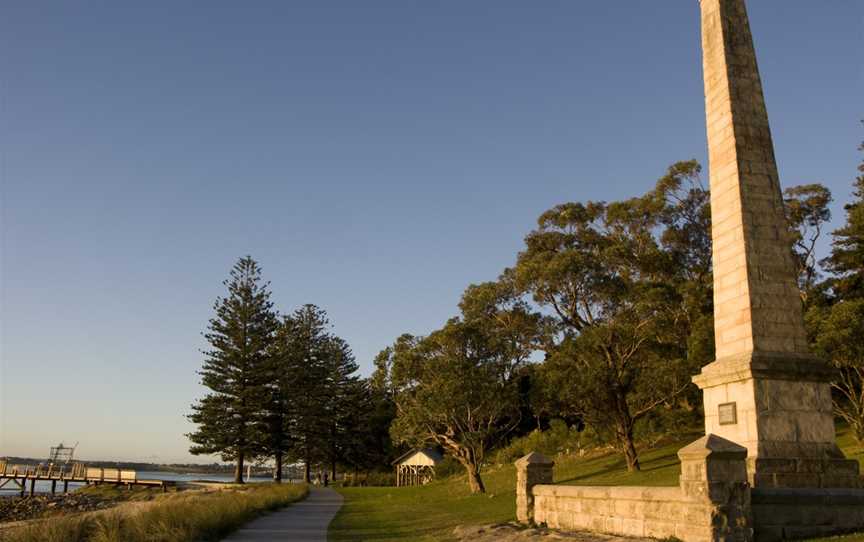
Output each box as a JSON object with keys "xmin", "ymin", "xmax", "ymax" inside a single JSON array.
[{"xmin": 0, "ymin": 484, "xmax": 308, "ymax": 542}]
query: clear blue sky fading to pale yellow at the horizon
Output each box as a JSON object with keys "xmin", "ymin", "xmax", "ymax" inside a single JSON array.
[{"xmin": 0, "ymin": 0, "xmax": 864, "ymax": 461}]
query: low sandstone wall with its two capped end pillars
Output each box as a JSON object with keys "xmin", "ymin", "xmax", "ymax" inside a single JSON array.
[{"xmin": 516, "ymin": 435, "xmax": 753, "ymax": 542}]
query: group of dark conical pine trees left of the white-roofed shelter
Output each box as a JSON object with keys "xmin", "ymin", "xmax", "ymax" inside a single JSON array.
[{"xmin": 188, "ymin": 264, "xmax": 370, "ymax": 483}]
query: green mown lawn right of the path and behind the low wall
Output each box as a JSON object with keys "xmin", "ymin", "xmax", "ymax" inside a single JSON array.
[{"xmin": 328, "ymin": 427, "xmax": 864, "ymax": 542}]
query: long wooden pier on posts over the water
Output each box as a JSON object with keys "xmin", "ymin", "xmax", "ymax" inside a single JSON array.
[{"xmin": 0, "ymin": 459, "xmax": 175, "ymax": 497}]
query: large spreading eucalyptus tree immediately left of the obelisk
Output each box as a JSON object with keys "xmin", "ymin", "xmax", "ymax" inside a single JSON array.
[{"xmin": 504, "ymin": 162, "xmax": 713, "ymax": 470}]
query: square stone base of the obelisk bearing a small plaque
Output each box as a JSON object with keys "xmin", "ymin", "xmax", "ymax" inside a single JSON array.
[{"xmin": 693, "ymin": 353, "xmax": 862, "ymax": 488}]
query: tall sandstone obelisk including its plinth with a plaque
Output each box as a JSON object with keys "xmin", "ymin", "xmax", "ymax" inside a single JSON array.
[{"xmin": 693, "ymin": 0, "xmax": 859, "ymax": 487}]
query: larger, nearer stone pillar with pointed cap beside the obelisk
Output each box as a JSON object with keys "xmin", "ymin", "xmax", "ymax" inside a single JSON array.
[{"xmin": 678, "ymin": 435, "xmax": 753, "ymax": 542}]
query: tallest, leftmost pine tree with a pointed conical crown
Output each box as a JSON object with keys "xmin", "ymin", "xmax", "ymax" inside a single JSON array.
[{"xmin": 187, "ymin": 256, "xmax": 277, "ymax": 483}]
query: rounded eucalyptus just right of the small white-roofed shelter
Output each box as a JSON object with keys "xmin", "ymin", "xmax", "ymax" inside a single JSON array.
[{"xmin": 388, "ymin": 283, "xmax": 539, "ymax": 493}]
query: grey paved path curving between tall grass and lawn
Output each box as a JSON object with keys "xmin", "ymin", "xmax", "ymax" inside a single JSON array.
[{"xmin": 224, "ymin": 487, "xmax": 342, "ymax": 542}]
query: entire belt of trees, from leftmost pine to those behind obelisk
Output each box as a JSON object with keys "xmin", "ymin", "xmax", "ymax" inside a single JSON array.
[{"xmin": 189, "ymin": 126, "xmax": 864, "ymax": 492}]
